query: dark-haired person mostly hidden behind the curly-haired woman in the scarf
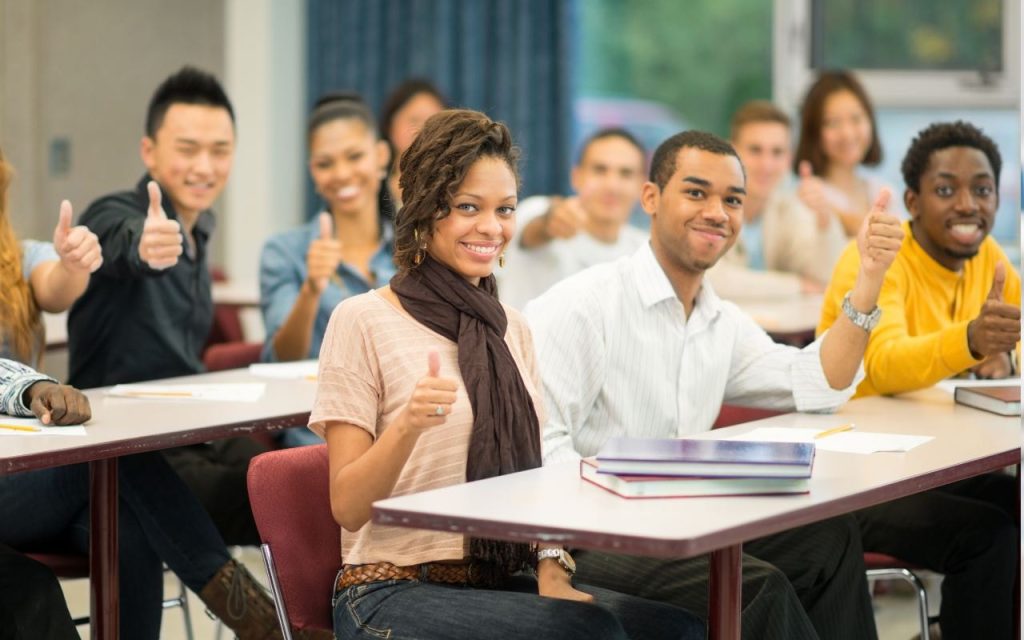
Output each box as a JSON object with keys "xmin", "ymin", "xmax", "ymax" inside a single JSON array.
[{"xmin": 380, "ymin": 78, "xmax": 449, "ymax": 206}]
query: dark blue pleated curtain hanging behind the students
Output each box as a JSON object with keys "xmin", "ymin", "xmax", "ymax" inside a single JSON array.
[{"xmin": 307, "ymin": 0, "xmax": 574, "ymax": 215}]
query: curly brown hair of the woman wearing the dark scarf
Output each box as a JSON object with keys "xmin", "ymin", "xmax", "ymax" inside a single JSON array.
[{"xmin": 394, "ymin": 109, "xmax": 519, "ymax": 272}]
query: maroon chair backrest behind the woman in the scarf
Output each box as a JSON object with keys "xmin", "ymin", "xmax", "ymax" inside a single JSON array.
[{"xmin": 249, "ymin": 444, "xmax": 341, "ymax": 629}]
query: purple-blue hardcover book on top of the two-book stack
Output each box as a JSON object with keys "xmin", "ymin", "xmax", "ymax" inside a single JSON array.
[{"xmin": 597, "ymin": 437, "xmax": 814, "ymax": 478}]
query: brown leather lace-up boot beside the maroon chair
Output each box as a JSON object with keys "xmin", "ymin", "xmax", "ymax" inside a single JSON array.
[{"xmin": 199, "ymin": 559, "xmax": 284, "ymax": 640}]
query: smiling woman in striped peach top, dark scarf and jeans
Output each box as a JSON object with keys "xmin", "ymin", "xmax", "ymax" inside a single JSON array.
[{"xmin": 309, "ymin": 110, "xmax": 703, "ymax": 640}]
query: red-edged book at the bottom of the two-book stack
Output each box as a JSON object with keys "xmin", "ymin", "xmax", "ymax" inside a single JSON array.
[{"xmin": 580, "ymin": 458, "xmax": 810, "ymax": 498}]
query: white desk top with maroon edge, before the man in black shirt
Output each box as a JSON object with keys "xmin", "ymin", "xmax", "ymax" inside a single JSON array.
[{"xmin": 0, "ymin": 369, "xmax": 316, "ymax": 473}]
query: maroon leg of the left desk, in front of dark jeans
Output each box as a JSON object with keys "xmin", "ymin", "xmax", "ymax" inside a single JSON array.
[{"xmin": 89, "ymin": 458, "xmax": 119, "ymax": 640}]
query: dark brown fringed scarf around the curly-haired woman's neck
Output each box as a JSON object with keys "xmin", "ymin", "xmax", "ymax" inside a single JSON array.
[{"xmin": 391, "ymin": 254, "xmax": 541, "ymax": 582}]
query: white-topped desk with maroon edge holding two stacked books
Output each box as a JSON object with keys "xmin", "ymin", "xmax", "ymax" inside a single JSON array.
[{"xmin": 373, "ymin": 388, "xmax": 1021, "ymax": 640}]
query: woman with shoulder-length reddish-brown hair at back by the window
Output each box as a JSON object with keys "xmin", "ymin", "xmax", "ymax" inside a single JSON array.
[{"xmin": 794, "ymin": 71, "xmax": 891, "ymax": 238}]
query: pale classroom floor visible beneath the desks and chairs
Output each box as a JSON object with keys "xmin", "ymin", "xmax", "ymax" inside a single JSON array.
[{"xmin": 62, "ymin": 547, "xmax": 939, "ymax": 640}]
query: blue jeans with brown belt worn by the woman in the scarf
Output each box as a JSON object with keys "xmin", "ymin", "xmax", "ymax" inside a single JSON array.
[{"xmin": 334, "ymin": 577, "xmax": 705, "ymax": 640}]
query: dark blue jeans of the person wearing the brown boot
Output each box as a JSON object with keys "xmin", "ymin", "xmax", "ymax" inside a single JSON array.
[{"xmin": 0, "ymin": 453, "xmax": 230, "ymax": 640}]
